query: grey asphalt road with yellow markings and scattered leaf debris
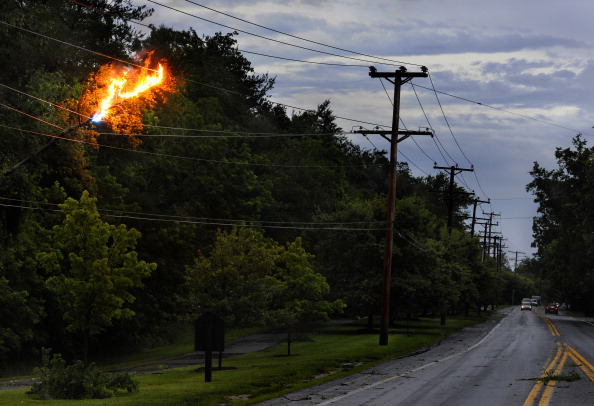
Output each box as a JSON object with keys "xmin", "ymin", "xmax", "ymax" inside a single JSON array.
[{"xmin": 260, "ymin": 306, "xmax": 594, "ymax": 406}]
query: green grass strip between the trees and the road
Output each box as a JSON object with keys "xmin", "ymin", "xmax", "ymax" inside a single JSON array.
[{"xmin": 0, "ymin": 317, "xmax": 484, "ymax": 406}]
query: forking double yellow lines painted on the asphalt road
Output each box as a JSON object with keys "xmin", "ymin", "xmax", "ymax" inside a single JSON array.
[{"xmin": 523, "ymin": 314, "xmax": 594, "ymax": 406}]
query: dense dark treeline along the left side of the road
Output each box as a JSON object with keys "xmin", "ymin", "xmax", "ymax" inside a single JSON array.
[{"xmin": 0, "ymin": 0, "xmax": 534, "ymax": 367}]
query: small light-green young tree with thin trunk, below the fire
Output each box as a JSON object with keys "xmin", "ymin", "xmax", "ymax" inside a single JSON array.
[{"xmin": 38, "ymin": 191, "xmax": 156, "ymax": 364}]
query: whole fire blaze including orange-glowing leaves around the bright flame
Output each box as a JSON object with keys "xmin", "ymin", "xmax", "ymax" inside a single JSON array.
[{"xmin": 80, "ymin": 53, "xmax": 173, "ymax": 145}]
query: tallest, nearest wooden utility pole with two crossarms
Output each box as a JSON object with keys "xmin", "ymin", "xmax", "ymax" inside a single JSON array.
[{"xmin": 355, "ymin": 66, "xmax": 426, "ymax": 345}]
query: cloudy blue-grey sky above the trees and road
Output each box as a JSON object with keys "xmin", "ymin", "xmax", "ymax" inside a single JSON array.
[{"xmin": 133, "ymin": 0, "xmax": 594, "ymax": 267}]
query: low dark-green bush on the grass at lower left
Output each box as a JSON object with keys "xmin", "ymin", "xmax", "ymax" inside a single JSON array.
[{"xmin": 27, "ymin": 349, "xmax": 139, "ymax": 399}]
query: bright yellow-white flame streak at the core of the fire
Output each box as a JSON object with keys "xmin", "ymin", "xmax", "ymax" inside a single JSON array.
[{"xmin": 92, "ymin": 57, "xmax": 165, "ymax": 122}]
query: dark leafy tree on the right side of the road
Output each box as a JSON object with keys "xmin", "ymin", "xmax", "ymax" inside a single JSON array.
[{"xmin": 527, "ymin": 135, "xmax": 594, "ymax": 314}]
